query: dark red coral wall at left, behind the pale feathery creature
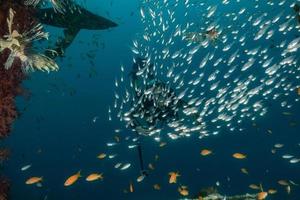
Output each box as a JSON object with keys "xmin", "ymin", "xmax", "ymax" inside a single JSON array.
[{"xmin": 0, "ymin": 0, "xmax": 37, "ymax": 139}]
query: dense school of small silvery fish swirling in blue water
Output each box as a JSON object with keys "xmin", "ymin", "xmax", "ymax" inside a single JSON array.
[{"xmin": 113, "ymin": 0, "xmax": 300, "ymax": 139}]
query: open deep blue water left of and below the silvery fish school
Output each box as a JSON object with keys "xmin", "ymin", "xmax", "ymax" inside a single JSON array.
[{"xmin": 3, "ymin": 0, "xmax": 300, "ymax": 200}]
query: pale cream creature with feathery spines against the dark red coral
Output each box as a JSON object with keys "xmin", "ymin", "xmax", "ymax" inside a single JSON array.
[{"xmin": 0, "ymin": 9, "xmax": 58, "ymax": 72}]
